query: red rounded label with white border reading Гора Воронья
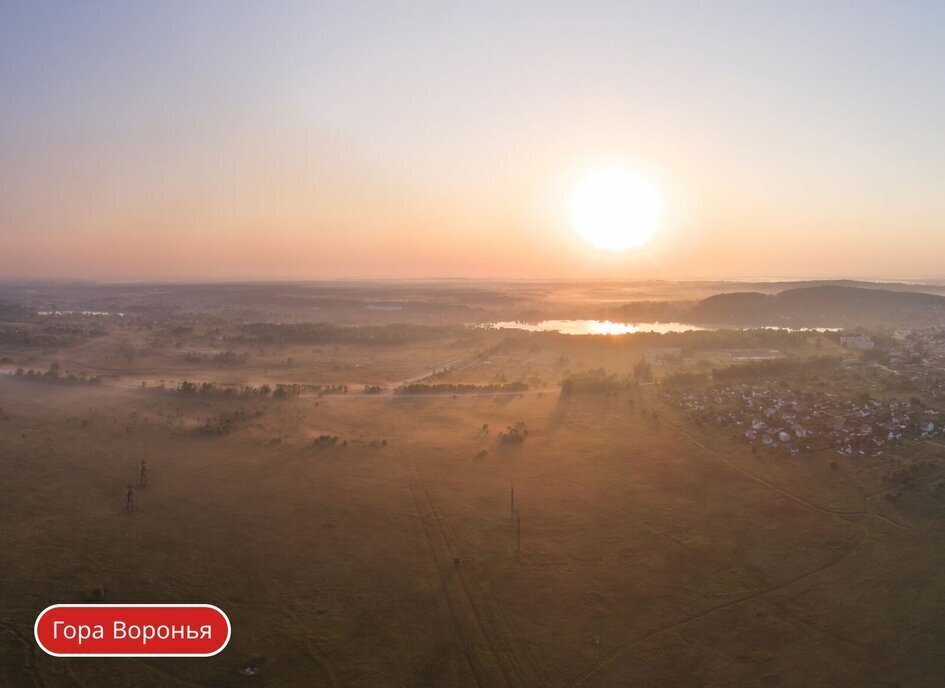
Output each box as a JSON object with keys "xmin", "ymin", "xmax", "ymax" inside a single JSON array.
[{"xmin": 33, "ymin": 604, "xmax": 230, "ymax": 657}]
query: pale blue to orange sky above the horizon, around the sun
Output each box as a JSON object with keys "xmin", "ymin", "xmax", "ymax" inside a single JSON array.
[{"xmin": 0, "ymin": 0, "xmax": 945, "ymax": 281}]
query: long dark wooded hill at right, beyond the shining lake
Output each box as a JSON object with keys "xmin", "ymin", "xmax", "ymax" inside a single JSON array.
[{"xmin": 689, "ymin": 285, "xmax": 945, "ymax": 327}]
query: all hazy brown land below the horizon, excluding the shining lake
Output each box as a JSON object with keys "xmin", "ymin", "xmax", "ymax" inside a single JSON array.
[{"xmin": 0, "ymin": 281, "xmax": 945, "ymax": 686}]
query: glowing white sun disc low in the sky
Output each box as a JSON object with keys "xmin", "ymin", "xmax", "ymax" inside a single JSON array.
[{"xmin": 571, "ymin": 168, "xmax": 662, "ymax": 251}]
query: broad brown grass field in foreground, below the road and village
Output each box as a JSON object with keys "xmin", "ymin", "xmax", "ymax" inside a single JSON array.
[{"xmin": 0, "ymin": 351, "xmax": 945, "ymax": 688}]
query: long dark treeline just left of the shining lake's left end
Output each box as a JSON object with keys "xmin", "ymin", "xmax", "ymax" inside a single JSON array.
[{"xmin": 230, "ymin": 323, "xmax": 463, "ymax": 345}]
